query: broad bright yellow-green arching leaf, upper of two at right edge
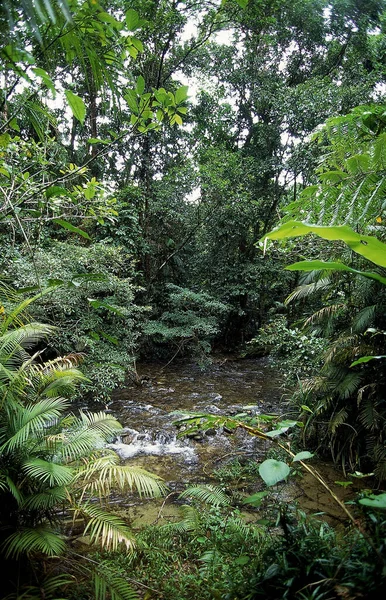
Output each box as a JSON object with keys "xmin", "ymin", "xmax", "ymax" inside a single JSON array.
[{"xmin": 263, "ymin": 221, "xmax": 386, "ymax": 267}]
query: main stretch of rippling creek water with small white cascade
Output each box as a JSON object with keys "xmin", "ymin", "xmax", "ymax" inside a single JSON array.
[{"xmin": 110, "ymin": 359, "xmax": 283, "ymax": 487}]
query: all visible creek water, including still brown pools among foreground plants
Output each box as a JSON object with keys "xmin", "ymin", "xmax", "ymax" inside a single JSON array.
[{"xmin": 106, "ymin": 358, "xmax": 358, "ymax": 524}]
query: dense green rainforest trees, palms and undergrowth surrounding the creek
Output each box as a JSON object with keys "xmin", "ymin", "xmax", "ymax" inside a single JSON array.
[{"xmin": 0, "ymin": 0, "xmax": 386, "ymax": 600}]
